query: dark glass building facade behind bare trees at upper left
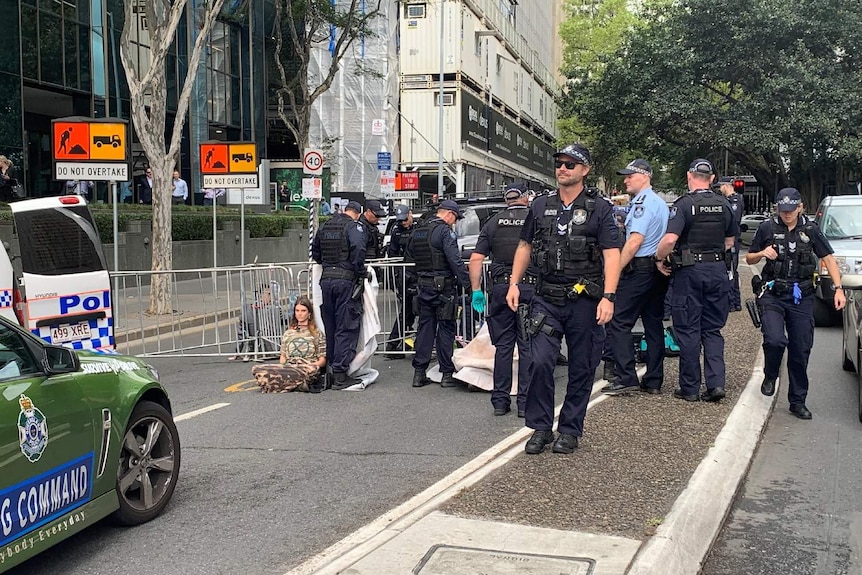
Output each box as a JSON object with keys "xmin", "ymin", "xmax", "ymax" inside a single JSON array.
[{"xmin": 0, "ymin": 0, "xmax": 266, "ymax": 199}]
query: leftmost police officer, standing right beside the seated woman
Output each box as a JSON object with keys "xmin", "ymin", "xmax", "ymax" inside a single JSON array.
[{"xmin": 311, "ymin": 202, "xmax": 367, "ymax": 390}]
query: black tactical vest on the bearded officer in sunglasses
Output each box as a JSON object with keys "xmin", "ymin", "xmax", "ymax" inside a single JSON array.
[{"xmin": 532, "ymin": 188, "xmax": 602, "ymax": 282}]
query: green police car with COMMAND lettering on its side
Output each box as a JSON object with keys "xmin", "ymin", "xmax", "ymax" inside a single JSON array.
[{"xmin": 0, "ymin": 317, "xmax": 180, "ymax": 573}]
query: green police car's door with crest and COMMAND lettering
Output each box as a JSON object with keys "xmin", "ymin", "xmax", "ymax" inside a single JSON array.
[{"xmin": 0, "ymin": 321, "xmax": 94, "ymax": 572}]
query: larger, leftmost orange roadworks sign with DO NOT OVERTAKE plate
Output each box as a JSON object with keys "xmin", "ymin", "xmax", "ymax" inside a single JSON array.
[{"xmin": 51, "ymin": 116, "xmax": 129, "ymax": 181}]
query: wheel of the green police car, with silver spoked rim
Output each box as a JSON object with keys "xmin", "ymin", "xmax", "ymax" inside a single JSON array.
[{"xmin": 114, "ymin": 401, "xmax": 180, "ymax": 525}]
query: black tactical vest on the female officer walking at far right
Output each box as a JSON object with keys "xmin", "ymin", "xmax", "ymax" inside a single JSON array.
[{"xmin": 761, "ymin": 215, "xmax": 817, "ymax": 281}]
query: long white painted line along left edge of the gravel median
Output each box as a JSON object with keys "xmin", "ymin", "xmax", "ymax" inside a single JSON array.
[{"xmin": 285, "ymin": 367, "xmax": 646, "ymax": 575}]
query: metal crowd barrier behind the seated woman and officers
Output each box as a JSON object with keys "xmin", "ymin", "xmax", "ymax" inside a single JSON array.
[{"xmin": 111, "ymin": 258, "xmax": 488, "ymax": 359}]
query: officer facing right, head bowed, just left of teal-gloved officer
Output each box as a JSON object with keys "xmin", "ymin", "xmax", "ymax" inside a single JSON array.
[{"xmin": 407, "ymin": 200, "xmax": 470, "ymax": 387}]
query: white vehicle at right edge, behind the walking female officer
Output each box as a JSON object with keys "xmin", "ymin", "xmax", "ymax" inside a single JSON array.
[{"xmin": 814, "ymin": 196, "xmax": 862, "ymax": 326}]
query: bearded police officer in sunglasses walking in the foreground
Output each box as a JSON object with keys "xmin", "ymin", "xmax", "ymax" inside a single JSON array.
[{"xmin": 506, "ymin": 144, "xmax": 620, "ymax": 454}]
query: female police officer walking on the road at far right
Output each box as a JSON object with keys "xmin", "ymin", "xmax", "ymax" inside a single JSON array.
[{"xmin": 745, "ymin": 188, "xmax": 846, "ymax": 419}]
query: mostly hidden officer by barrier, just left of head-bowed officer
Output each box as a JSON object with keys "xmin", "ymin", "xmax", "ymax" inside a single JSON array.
[{"xmin": 386, "ymin": 204, "xmax": 416, "ymax": 359}]
